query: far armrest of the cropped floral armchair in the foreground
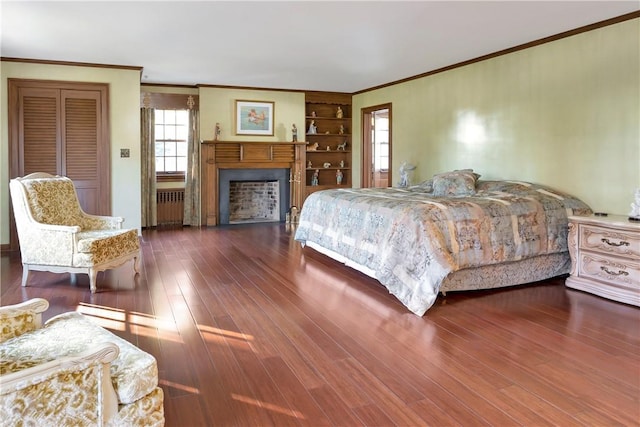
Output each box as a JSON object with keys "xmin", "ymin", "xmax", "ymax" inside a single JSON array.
[{"xmin": 0, "ymin": 298, "xmax": 49, "ymax": 343}]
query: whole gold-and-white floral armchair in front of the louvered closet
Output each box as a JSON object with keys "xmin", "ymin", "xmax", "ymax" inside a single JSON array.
[{"xmin": 9, "ymin": 172, "xmax": 140, "ymax": 293}]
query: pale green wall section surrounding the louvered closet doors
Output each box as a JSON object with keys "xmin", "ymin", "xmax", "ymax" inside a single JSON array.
[{"xmin": 0, "ymin": 61, "xmax": 141, "ymax": 244}]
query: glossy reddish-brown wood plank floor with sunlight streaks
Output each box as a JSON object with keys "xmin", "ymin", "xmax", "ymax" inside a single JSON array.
[{"xmin": 1, "ymin": 224, "xmax": 640, "ymax": 426}]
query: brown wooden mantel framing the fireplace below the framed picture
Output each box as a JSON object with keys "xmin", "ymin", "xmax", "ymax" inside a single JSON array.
[{"xmin": 201, "ymin": 141, "xmax": 306, "ymax": 226}]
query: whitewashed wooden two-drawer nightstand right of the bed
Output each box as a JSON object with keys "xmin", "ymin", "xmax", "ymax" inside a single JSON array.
[{"xmin": 566, "ymin": 215, "xmax": 640, "ymax": 306}]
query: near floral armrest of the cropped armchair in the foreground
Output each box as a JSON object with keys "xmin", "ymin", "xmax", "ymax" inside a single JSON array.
[{"xmin": 0, "ymin": 343, "xmax": 119, "ymax": 425}]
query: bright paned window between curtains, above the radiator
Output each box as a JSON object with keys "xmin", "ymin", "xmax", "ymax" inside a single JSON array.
[{"xmin": 155, "ymin": 110, "xmax": 189, "ymax": 179}]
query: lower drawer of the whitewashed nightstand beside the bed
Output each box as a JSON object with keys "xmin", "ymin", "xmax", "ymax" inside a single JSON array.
[{"xmin": 578, "ymin": 252, "xmax": 640, "ymax": 289}]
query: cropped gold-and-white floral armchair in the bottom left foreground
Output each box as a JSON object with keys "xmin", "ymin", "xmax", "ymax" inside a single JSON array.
[{"xmin": 0, "ymin": 298, "xmax": 164, "ymax": 427}]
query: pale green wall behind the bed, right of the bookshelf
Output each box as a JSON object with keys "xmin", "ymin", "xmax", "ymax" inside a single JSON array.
[{"xmin": 353, "ymin": 19, "xmax": 640, "ymax": 215}]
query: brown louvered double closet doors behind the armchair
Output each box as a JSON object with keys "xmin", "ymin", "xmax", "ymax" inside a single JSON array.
[{"xmin": 9, "ymin": 81, "xmax": 111, "ymax": 215}]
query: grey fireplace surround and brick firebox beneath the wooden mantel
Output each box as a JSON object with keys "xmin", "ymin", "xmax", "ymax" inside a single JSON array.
[{"xmin": 218, "ymin": 168, "xmax": 290, "ymax": 224}]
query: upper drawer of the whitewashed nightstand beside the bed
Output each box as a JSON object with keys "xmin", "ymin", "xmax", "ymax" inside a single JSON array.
[{"xmin": 580, "ymin": 224, "xmax": 640, "ymax": 260}]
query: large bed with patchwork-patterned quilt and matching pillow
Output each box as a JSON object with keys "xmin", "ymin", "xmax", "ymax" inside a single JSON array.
[{"xmin": 295, "ymin": 169, "xmax": 591, "ymax": 316}]
